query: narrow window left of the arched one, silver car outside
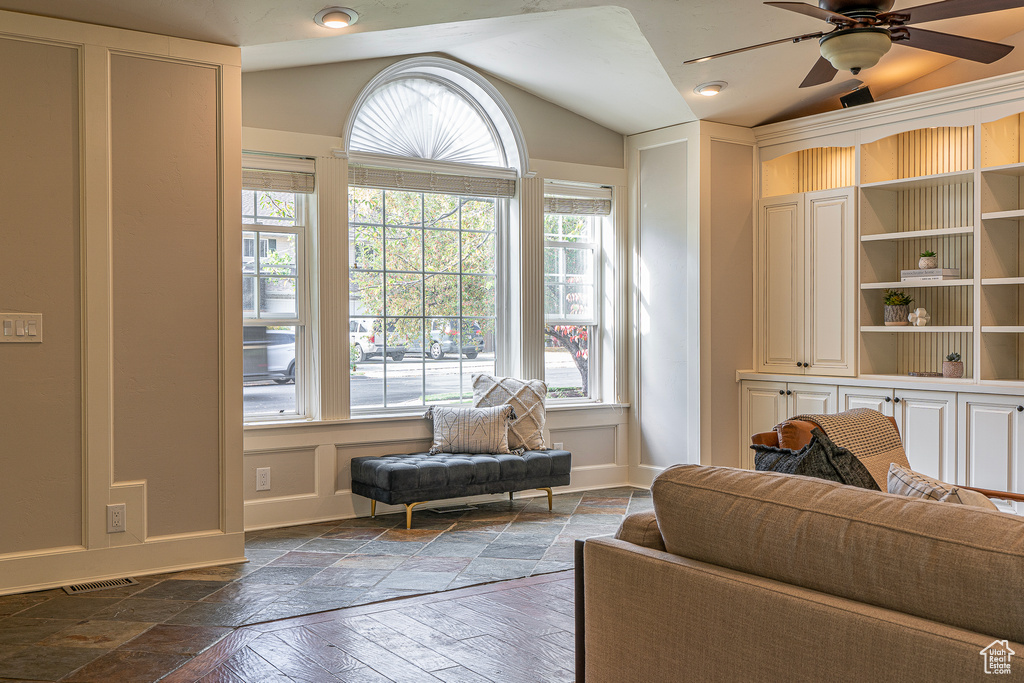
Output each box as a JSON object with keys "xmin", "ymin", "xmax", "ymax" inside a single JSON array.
[{"xmin": 242, "ymin": 189, "xmax": 307, "ymax": 419}]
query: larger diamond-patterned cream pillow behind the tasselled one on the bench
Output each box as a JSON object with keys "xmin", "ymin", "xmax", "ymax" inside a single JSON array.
[{"xmin": 473, "ymin": 375, "xmax": 548, "ymax": 451}]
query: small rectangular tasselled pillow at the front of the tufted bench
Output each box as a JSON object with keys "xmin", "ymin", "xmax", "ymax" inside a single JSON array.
[{"xmin": 423, "ymin": 405, "xmax": 515, "ymax": 454}]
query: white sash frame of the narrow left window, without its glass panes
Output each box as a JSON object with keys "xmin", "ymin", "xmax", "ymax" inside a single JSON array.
[{"xmin": 240, "ymin": 187, "xmax": 315, "ymax": 424}]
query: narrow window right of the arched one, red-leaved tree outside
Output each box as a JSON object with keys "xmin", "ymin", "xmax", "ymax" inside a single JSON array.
[{"xmin": 544, "ymin": 183, "xmax": 611, "ymax": 399}]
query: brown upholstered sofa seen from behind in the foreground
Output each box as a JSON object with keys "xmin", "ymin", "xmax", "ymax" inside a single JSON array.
[{"xmin": 577, "ymin": 465, "xmax": 1024, "ymax": 683}]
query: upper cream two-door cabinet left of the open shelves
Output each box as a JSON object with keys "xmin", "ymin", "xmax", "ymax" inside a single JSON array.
[{"xmin": 756, "ymin": 187, "xmax": 856, "ymax": 376}]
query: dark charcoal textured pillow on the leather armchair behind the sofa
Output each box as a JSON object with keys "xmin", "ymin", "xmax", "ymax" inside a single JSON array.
[{"xmin": 751, "ymin": 427, "xmax": 880, "ymax": 490}]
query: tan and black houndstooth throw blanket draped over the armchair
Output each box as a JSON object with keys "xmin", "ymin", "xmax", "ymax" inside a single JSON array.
[{"xmin": 790, "ymin": 408, "xmax": 910, "ymax": 490}]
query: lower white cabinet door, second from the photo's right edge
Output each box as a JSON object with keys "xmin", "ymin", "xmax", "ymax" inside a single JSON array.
[{"xmin": 895, "ymin": 389, "xmax": 956, "ymax": 483}]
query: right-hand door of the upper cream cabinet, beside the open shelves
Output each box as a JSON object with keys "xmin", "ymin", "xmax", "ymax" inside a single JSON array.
[{"xmin": 802, "ymin": 188, "xmax": 856, "ymax": 376}]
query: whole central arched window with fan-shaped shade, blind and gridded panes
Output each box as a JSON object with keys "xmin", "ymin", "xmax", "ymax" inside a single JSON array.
[{"xmin": 346, "ymin": 58, "xmax": 527, "ymax": 412}]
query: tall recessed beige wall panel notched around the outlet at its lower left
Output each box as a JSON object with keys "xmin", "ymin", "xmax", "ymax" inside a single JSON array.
[{"xmin": 111, "ymin": 55, "xmax": 220, "ymax": 536}]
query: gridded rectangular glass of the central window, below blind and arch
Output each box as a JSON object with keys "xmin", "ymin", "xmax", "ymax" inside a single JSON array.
[{"xmin": 349, "ymin": 187, "xmax": 504, "ymax": 410}]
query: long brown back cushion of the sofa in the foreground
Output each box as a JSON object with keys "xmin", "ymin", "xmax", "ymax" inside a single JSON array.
[{"xmin": 651, "ymin": 465, "xmax": 1024, "ymax": 642}]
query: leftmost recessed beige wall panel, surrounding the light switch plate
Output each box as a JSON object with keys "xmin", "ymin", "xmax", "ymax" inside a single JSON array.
[{"xmin": 0, "ymin": 39, "xmax": 82, "ymax": 554}]
